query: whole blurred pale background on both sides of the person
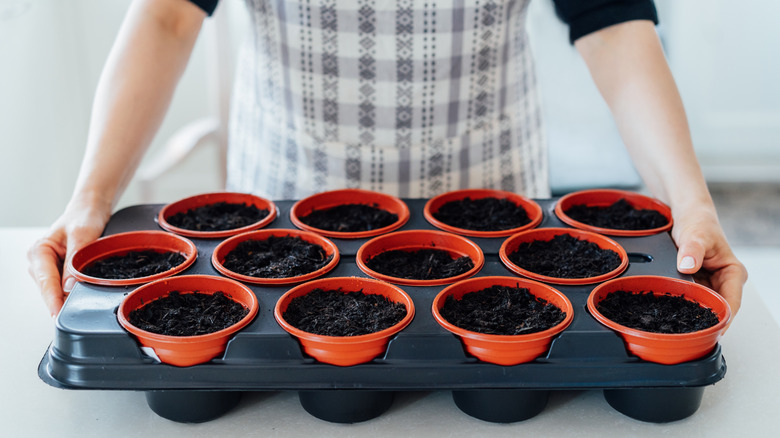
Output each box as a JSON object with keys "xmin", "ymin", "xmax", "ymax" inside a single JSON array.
[{"xmin": 0, "ymin": 0, "xmax": 780, "ymax": 314}]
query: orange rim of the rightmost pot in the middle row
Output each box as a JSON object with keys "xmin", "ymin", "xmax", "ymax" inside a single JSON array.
[{"xmin": 498, "ymin": 228, "xmax": 628, "ymax": 285}]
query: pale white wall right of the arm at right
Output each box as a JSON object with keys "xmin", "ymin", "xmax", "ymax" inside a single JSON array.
[{"xmin": 657, "ymin": 0, "xmax": 780, "ymax": 182}]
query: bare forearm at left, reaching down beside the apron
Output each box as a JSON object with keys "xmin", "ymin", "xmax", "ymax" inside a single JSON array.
[{"xmin": 72, "ymin": 0, "xmax": 204, "ymax": 210}]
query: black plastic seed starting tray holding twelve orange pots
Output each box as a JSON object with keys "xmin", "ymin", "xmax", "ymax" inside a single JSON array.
[{"xmin": 38, "ymin": 199, "xmax": 726, "ymax": 422}]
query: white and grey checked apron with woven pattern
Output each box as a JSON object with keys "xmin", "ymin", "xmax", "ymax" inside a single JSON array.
[{"xmin": 227, "ymin": 0, "xmax": 550, "ymax": 199}]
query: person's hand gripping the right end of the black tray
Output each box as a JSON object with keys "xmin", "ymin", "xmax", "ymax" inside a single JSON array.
[{"xmin": 672, "ymin": 209, "xmax": 747, "ymax": 318}]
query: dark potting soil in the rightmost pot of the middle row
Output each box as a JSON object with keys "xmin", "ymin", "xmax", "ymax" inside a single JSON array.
[{"xmin": 509, "ymin": 234, "xmax": 620, "ymax": 278}]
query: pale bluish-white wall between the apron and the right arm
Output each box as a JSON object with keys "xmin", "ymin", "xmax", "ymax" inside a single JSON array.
[{"xmin": 528, "ymin": 0, "xmax": 641, "ymax": 193}]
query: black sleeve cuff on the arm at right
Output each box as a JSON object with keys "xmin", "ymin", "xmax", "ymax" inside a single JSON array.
[{"xmin": 569, "ymin": 1, "xmax": 658, "ymax": 43}]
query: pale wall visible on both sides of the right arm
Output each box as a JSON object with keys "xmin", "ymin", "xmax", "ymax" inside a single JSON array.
[{"xmin": 528, "ymin": 0, "xmax": 780, "ymax": 190}]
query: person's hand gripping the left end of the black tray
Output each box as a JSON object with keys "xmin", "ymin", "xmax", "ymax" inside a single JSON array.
[{"xmin": 27, "ymin": 200, "xmax": 111, "ymax": 317}]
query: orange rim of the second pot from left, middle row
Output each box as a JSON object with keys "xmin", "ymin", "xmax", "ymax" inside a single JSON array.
[{"xmin": 211, "ymin": 228, "xmax": 339, "ymax": 285}]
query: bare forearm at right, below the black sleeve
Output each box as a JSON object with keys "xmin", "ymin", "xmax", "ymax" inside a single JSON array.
[{"xmin": 575, "ymin": 21, "xmax": 714, "ymax": 221}]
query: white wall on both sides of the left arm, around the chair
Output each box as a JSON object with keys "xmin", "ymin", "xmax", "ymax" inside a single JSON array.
[{"xmin": 0, "ymin": 0, "xmax": 220, "ymax": 226}]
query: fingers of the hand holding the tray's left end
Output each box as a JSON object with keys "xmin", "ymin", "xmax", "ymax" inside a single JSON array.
[{"xmin": 27, "ymin": 238, "xmax": 65, "ymax": 316}]
